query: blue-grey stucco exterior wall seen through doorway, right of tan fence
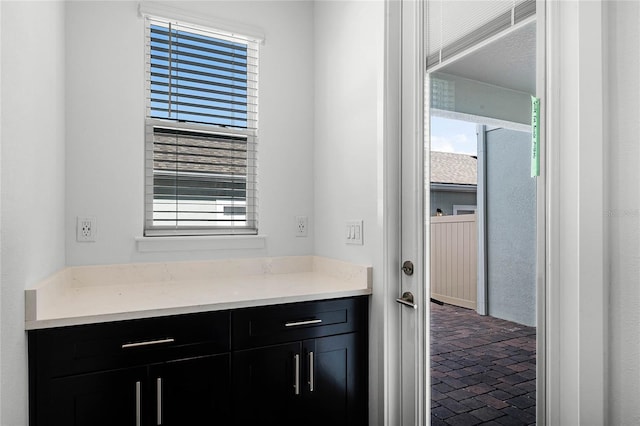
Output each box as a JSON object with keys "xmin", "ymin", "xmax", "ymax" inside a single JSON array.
[{"xmin": 485, "ymin": 129, "xmax": 536, "ymax": 326}]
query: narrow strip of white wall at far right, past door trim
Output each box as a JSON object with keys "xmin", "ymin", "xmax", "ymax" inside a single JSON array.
[{"xmin": 605, "ymin": 2, "xmax": 640, "ymax": 425}]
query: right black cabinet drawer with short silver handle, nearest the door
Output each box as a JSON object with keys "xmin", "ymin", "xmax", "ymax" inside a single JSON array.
[{"xmin": 232, "ymin": 297, "xmax": 367, "ymax": 349}]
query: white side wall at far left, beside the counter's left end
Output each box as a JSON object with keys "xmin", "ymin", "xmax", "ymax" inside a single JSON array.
[{"xmin": 0, "ymin": 2, "xmax": 65, "ymax": 426}]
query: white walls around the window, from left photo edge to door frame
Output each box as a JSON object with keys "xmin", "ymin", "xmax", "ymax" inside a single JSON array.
[{"xmin": 0, "ymin": 1, "xmax": 384, "ymax": 426}]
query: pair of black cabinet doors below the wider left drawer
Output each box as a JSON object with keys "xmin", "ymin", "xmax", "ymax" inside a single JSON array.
[{"xmin": 47, "ymin": 355, "xmax": 231, "ymax": 426}]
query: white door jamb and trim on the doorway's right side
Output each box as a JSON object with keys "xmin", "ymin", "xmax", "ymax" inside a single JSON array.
[{"xmin": 537, "ymin": 0, "xmax": 609, "ymax": 424}]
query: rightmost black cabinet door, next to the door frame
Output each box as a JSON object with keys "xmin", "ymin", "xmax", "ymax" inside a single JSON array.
[{"xmin": 304, "ymin": 333, "xmax": 367, "ymax": 426}]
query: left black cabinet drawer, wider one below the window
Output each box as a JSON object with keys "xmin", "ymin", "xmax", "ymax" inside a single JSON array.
[{"xmin": 29, "ymin": 311, "xmax": 230, "ymax": 377}]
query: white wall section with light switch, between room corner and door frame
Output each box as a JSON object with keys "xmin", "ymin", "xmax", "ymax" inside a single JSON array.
[{"xmin": 314, "ymin": 1, "xmax": 385, "ymax": 425}]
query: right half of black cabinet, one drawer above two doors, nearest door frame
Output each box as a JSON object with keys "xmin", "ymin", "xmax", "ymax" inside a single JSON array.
[{"xmin": 232, "ymin": 299, "xmax": 367, "ymax": 426}]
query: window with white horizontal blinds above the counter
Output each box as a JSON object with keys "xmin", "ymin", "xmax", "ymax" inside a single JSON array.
[{"xmin": 145, "ymin": 17, "xmax": 258, "ymax": 236}]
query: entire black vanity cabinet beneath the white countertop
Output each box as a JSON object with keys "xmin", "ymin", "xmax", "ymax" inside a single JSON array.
[{"xmin": 29, "ymin": 296, "xmax": 368, "ymax": 426}]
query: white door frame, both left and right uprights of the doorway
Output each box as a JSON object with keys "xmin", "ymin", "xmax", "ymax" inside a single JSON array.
[{"xmin": 381, "ymin": 0, "xmax": 608, "ymax": 426}]
